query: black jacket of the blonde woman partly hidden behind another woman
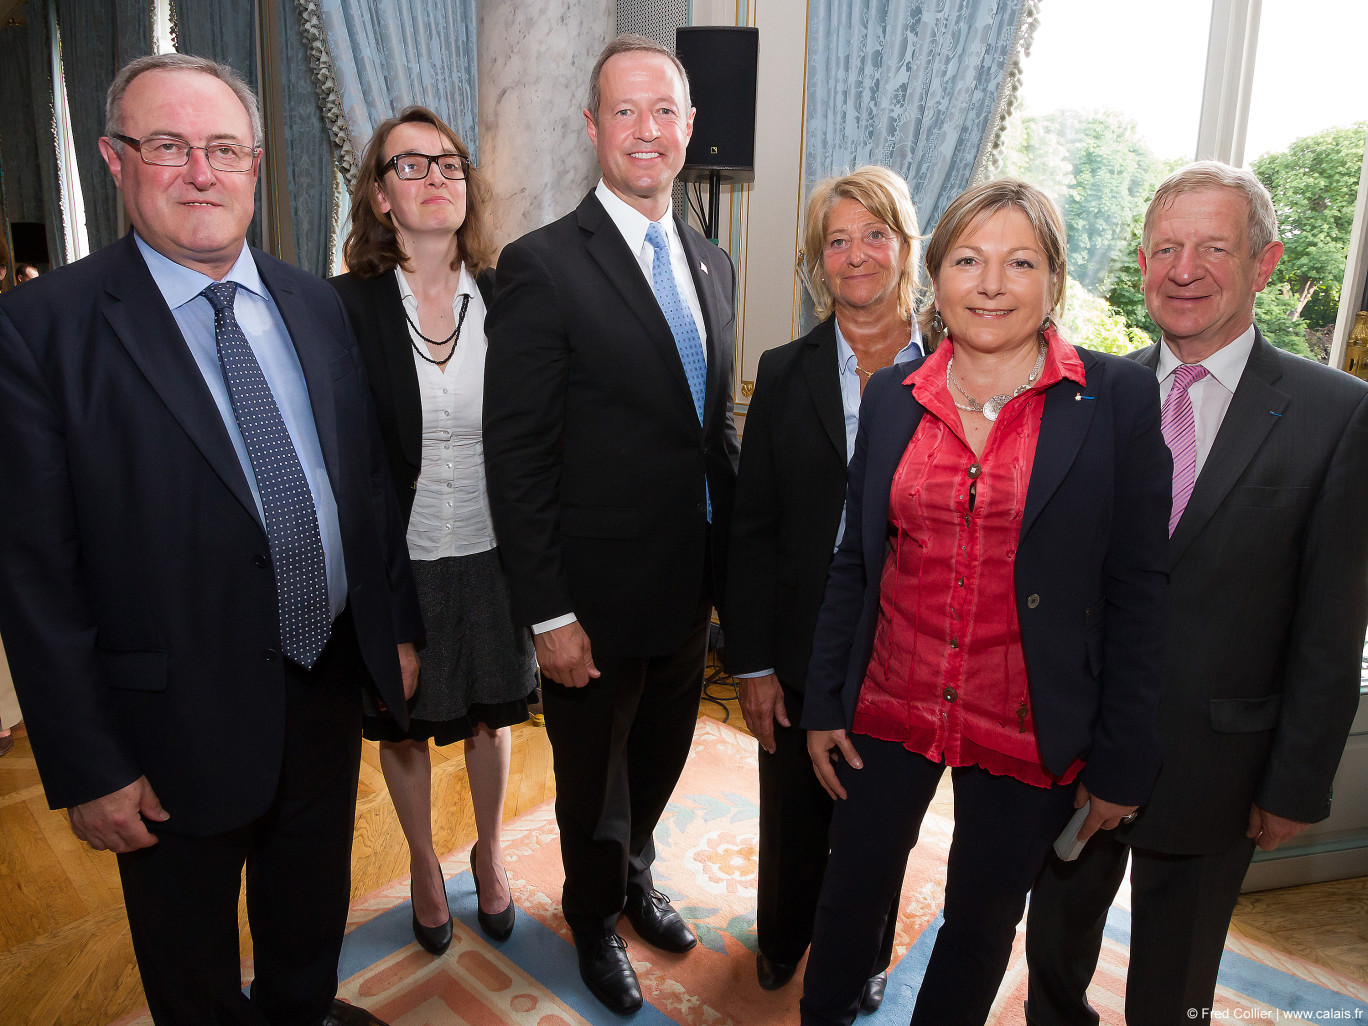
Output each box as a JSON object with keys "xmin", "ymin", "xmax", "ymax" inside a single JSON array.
[{"xmin": 726, "ymin": 317, "xmax": 845, "ymax": 691}]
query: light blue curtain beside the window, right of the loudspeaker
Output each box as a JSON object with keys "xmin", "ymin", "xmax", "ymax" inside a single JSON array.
[{"xmin": 803, "ymin": 0, "xmax": 1033, "ymax": 231}]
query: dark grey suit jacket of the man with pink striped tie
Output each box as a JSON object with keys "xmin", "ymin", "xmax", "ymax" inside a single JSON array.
[{"xmin": 1118, "ymin": 335, "xmax": 1368, "ymax": 854}]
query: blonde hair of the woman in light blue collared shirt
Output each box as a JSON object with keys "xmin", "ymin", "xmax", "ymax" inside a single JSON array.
[{"xmin": 802, "ymin": 164, "xmax": 922, "ymax": 320}]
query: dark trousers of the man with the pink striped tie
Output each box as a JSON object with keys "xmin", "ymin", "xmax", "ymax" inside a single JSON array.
[{"xmin": 1026, "ymin": 832, "xmax": 1254, "ymax": 1026}]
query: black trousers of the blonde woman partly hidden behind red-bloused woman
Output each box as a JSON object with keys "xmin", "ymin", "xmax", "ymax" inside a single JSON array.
[{"xmin": 755, "ymin": 688, "xmax": 907, "ymax": 977}]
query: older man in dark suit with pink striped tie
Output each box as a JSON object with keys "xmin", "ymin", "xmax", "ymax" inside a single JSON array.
[{"xmin": 1026, "ymin": 161, "xmax": 1368, "ymax": 1026}]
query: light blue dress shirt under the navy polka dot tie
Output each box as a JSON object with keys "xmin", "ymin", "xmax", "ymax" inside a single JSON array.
[{"xmin": 134, "ymin": 234, "xmax": 346, "ymax": 618}]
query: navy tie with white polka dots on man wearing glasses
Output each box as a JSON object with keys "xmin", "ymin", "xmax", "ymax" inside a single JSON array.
[{"xmin": 201, "ymin": 282, "xmax": 332, "ymax": 668}]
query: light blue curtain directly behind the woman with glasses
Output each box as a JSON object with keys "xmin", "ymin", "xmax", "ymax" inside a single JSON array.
[{"xmin": 307, "ymin": 0, "xmax": 479, "ymax": 183}]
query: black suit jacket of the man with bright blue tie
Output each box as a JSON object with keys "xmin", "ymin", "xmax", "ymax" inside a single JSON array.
[{"xmin": 484, "ymin": 193, "xmax": 739, "ymax": 657}]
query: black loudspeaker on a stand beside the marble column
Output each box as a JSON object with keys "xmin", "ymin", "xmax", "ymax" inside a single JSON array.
[{"xmin": 674, "ymin": 25, "xmax": 759, "ymax": 182}]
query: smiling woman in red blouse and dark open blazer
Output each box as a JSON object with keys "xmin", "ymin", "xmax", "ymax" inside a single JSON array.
[{"xmin": 802, "ymin": 181, "xmax": 1171, "ymax": 1026}]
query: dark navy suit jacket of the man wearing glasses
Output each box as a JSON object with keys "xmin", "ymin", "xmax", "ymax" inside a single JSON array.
[{"xmin": 0, "ymin": 233, "xmax": 421, "ymax": 833}]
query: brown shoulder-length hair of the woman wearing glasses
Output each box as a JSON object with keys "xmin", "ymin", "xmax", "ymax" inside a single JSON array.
[{"xmin": 342, "ymin": 107, "xmax": 494, "ymax": 278}]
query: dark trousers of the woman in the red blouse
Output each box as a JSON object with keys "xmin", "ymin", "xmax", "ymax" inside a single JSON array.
[{"xmin": 800, "ymin": 735, "xmax": 1075, "ymax": 1026}]
